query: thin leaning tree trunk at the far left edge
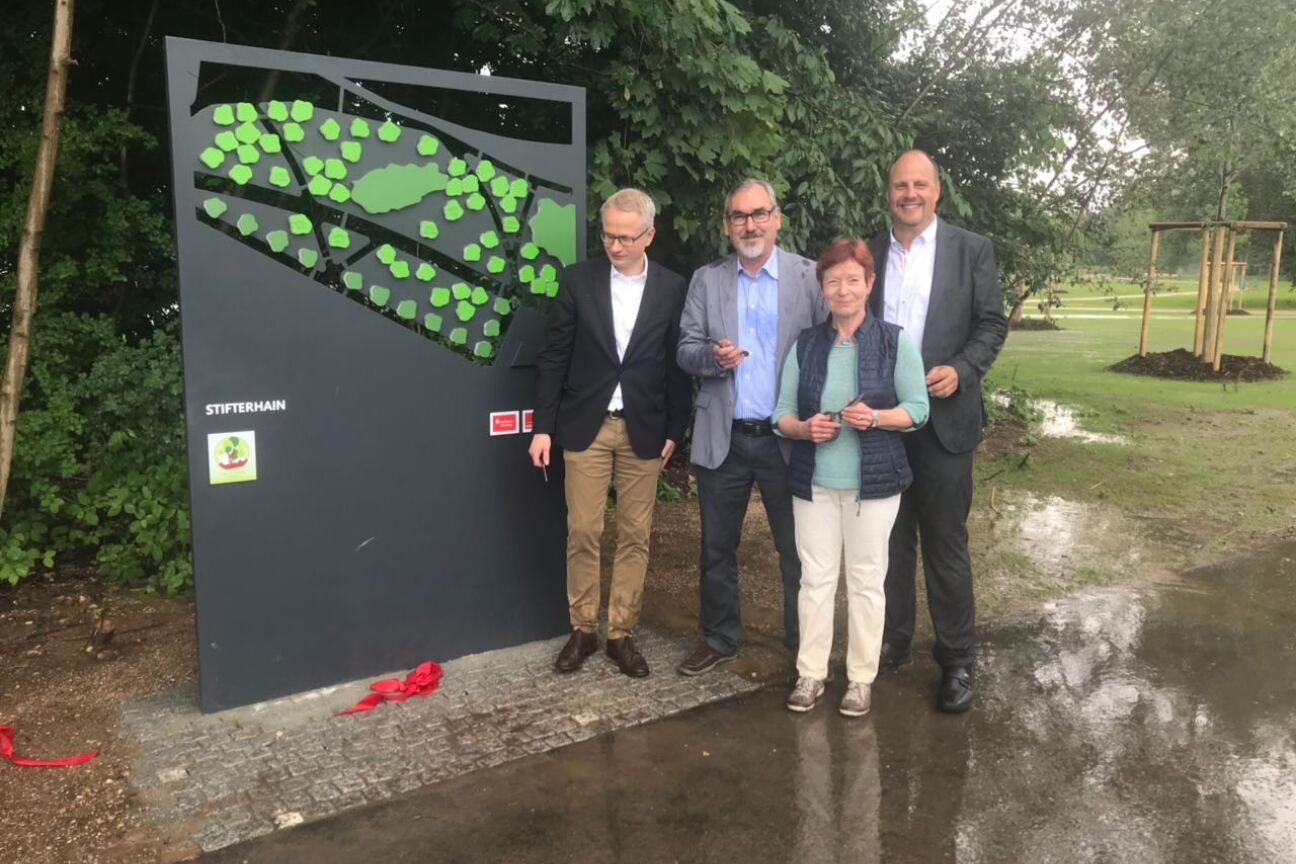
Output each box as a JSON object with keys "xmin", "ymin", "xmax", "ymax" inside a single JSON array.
[{"xmin": 0, "ymin": 0, "xmax": 73, "ymax": 513}]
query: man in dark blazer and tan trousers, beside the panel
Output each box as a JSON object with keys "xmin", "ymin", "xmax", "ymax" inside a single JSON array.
[{"xmin": 529, "ymin": 189, "xmax": 691, "ymax": 677}]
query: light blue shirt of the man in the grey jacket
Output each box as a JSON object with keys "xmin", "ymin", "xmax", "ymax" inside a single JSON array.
[{"xmin": 734, "ymin": 247, "xmax": 779, "ymax": 420}]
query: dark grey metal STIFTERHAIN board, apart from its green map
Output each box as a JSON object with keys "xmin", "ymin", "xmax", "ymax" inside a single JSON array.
[{"xmin": 167, "ymin": 39, "xmax": 584, "ymax": 710}]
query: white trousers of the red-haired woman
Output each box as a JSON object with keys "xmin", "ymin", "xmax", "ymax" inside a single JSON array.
[{"xmin": 792, "ymin": 486, "xmax": 899, "ymax": 684}]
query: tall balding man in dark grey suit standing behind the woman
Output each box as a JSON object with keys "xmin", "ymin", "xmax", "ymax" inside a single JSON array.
[{"xmin": 868, "ymin": 150, "xmax": 1008, "ymax": 714}]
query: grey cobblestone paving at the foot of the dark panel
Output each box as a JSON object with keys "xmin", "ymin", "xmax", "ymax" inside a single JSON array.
[{"xmin": 121, "ymin": 627, "xmax": 757, "ymax": 851}]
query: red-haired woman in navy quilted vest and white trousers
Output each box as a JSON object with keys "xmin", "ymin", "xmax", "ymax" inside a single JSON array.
[{"xmin": 772, "ymin": 240, "xmax": 928, "ymax": 716}]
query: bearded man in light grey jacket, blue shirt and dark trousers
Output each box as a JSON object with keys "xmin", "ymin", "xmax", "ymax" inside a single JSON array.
[{"xmin": 677, "ymin": 180, "xmax": 828, "ymax": 675}]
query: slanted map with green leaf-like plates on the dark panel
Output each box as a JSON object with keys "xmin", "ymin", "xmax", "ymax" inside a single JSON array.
[{"xmin": 193, "ymin": 82, "xmax": 577, "ymax": 365}]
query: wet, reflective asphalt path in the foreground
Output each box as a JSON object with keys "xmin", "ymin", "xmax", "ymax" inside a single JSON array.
[{"xmin": 201, "ymin": 543, "xmax": 1296, "ymax": 864}]
